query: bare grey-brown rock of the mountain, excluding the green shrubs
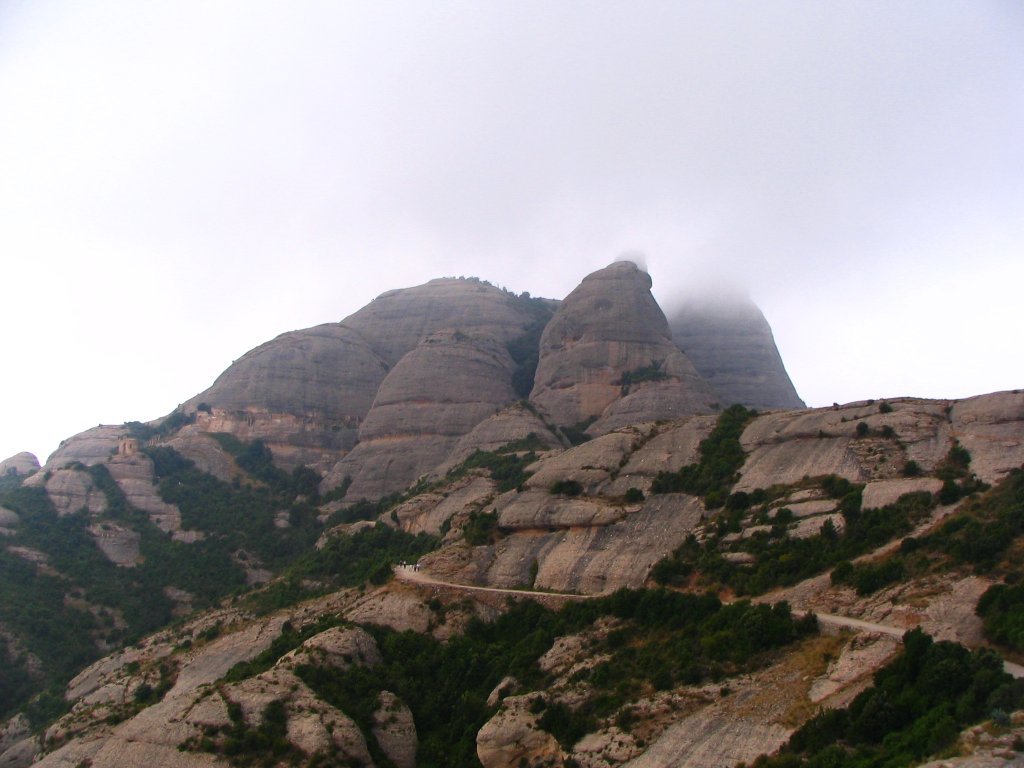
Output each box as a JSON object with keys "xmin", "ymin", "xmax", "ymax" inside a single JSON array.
[{"xmin": 0, "ymin": 264, "xmax": 1024, "ymax": 768}]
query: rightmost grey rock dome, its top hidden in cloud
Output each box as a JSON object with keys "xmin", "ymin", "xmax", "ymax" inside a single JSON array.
[{"xmin": 669, "ymin": 297, "xmax": 804, "ymax": 409}]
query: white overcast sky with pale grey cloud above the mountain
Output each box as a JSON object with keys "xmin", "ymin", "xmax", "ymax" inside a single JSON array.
[{"xmin": 0, "ymin": 0, "xmax": 1024, "ymax": 460}]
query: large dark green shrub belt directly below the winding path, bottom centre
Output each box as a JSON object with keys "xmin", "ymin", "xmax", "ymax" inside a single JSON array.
[{"xmin": 298, "ymin": 590, "xmax": 815, "ymax": 768}]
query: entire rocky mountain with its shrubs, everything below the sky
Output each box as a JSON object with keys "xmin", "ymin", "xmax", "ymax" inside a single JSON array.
[{"xmin": 0, "ymin": 262, "xmax": 1024, "ymax": 768}]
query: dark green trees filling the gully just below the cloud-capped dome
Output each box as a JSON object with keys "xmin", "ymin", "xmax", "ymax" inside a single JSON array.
[{"xmin": 651, "ymin": 404, "xmax": 757, "ymax": 508}]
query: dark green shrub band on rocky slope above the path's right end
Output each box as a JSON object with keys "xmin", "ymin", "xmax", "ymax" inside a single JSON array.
[{"xmin": 651, "ymin": 489, "xmax": 934, "ymax": 595}]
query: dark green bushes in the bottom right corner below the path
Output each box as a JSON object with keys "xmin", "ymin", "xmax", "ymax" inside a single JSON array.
[{"xmin": 754, "ymin": 630, "xmax": 1024, "ymax": 768}]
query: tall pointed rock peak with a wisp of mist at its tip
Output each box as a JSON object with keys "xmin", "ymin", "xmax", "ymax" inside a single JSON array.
[{"xmin": 530, "ymin": 261, "xmax": 715, "ymax": 433}]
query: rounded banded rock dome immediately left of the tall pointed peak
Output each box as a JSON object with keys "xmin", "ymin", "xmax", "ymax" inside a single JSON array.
[{"xmin": 324, "ymin": 331, "xmax": 515, "ymax": 499}]
